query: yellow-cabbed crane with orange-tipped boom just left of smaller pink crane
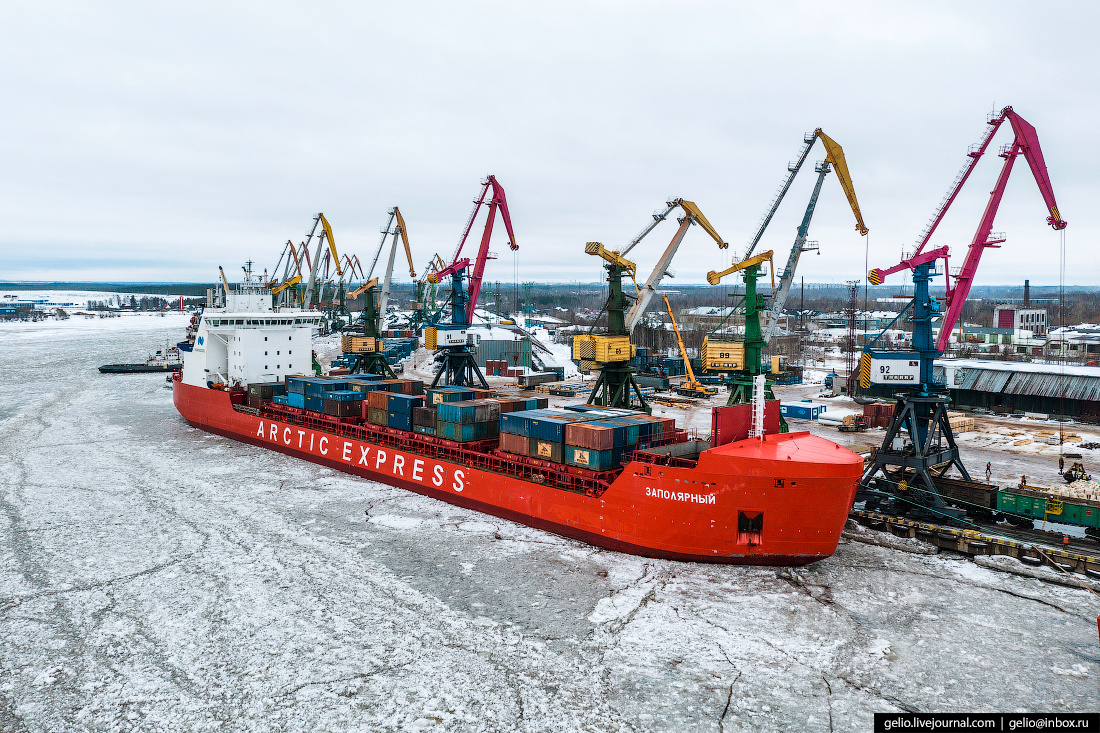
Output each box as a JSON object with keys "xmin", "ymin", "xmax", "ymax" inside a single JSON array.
[{"xmin": 342, "ymin": 206, "xmax": 416, "ymax": 379}]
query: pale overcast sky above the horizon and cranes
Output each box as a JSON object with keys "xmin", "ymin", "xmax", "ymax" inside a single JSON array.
[{"xmin": 0, "ymin": 1, "xmax": 1100, "ymax": 284}]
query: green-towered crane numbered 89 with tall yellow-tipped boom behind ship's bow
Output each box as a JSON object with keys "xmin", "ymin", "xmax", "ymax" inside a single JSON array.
[{"xmin": 703, "ymin": 128, "xmax": 868, "ymax": 404}]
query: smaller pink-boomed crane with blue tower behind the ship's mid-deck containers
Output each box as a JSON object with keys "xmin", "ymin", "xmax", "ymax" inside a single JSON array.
[{"xmin": 425, "ymin": 175, "xmax": 519, "ymax": 390}]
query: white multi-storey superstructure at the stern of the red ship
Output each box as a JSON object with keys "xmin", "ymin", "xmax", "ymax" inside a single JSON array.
[{"xmin": 183, "ymin": 275, "xmax": 325, "ymax": 386}]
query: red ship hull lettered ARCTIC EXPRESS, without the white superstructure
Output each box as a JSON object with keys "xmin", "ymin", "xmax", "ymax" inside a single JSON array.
[{"xmin": 173, "ymin": 381, "xmax": 862, "ymax": 566}]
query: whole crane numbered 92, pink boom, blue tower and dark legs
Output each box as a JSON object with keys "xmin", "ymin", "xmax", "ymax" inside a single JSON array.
[{"xmin": 859, "ymin": 107, "xmax": 1066, "ymax": 514}]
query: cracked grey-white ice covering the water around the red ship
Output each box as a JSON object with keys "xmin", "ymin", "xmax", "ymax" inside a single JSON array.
[{"xmin": 0, "ymin": 318, "xmax": 1100, "ymax": 731}]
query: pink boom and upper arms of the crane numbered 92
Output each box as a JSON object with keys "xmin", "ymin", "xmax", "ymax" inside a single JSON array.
[{"xmin": 868, "ymin": 107, "xmax": 1066, "ymax": 352}]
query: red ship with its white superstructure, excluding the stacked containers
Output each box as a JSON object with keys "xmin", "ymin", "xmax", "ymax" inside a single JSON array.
[{"xmin": 173, "ymin": 277, "xmax": 864, "ymax": 565}]
